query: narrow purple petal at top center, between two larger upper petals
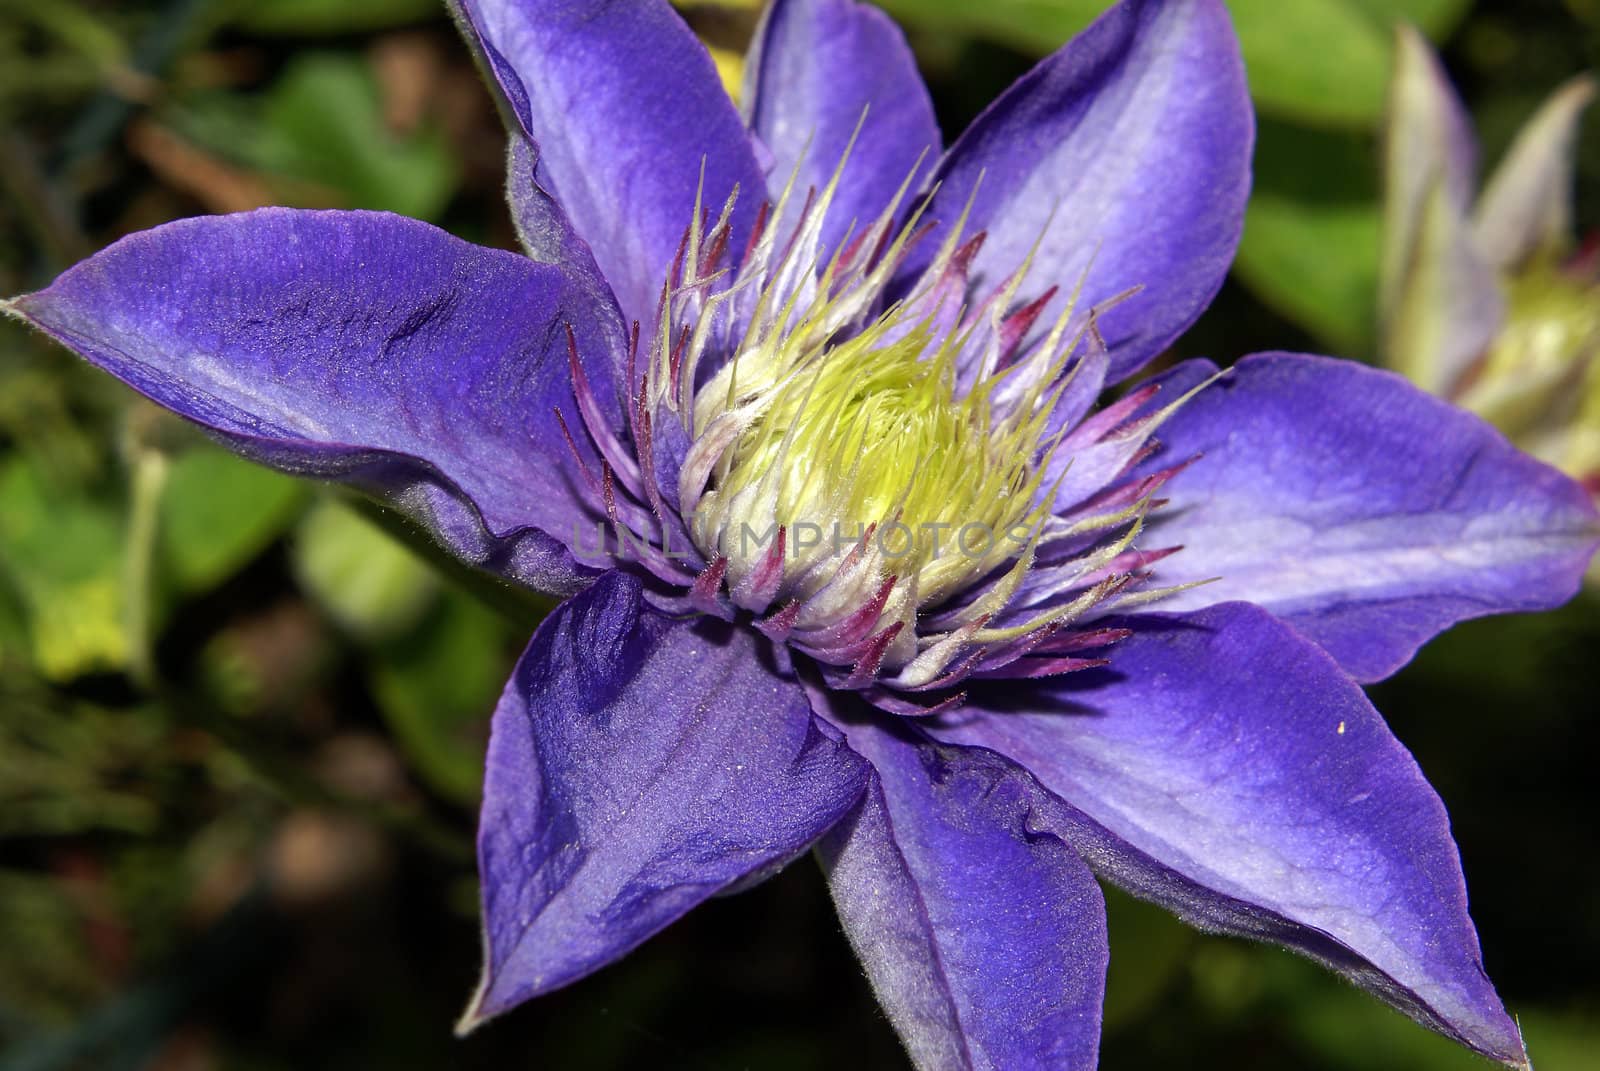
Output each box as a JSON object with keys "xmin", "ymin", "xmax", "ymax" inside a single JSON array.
[{"xmin": 746, "ymin": 0, "xmax": 942, "ymax": 263}]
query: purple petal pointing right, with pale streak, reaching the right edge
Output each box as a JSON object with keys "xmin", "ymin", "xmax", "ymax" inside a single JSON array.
[{"xmin": 1141, "ymin": 354, "xmax": 1600, "ymax": 680}]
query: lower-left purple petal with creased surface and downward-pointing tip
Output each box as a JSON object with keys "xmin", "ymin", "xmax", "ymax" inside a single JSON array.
[{"xmin": 461, "ymin": 572, "xmax": 867, "ymax": 1029}]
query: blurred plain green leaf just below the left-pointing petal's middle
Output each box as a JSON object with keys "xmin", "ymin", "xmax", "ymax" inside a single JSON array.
[{"xmin": 160, "ymin": 447, "xmax": 307, "ymax": 592}]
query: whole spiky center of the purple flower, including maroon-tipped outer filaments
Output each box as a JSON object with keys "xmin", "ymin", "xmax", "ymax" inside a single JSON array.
[{"xmin": 563, "ymin": 146, "xmax": 1192, "ymax": 712}]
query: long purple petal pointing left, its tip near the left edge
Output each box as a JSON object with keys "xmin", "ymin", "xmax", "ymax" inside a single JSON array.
[{"xmin": 10, "ymin": 208, "xmax": 621, "ymax": 592}]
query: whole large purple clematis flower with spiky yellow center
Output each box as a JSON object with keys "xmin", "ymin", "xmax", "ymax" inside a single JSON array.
[{"xmin": 8, "ymin": 0, "xmax": 1597, "ymax": 1068}]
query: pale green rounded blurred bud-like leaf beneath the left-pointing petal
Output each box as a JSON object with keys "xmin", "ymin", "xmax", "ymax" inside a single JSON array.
[{"xmin": 293, "ymin": 499, "xmax": 438, "ymax": 640}]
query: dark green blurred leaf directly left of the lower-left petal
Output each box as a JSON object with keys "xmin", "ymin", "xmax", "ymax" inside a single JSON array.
[{"xmin": 368, "ymin": 591, "xmax": 526, "ymax": 804}]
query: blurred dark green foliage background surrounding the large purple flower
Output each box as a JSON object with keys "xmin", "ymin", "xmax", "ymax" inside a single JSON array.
[{"xmin": 0, "ymin": 0, "xmax": 1600, "ymax": 1071}]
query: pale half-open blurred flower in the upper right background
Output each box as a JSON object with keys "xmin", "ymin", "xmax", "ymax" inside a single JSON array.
[{"xmin": 1382, "ymin": 30, "xmax": 1600, "ymax": 490}]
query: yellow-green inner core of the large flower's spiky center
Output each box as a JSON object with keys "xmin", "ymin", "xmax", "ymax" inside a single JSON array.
[{"xmin": 693, "ymin": 311, "xmax": 1048, "ymax": 604}]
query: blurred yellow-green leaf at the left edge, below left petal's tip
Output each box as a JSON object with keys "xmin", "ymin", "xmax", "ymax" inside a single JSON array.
[{"xmin": 0, "ymin": 456, "xmax": 130, "ymax": 680}]
